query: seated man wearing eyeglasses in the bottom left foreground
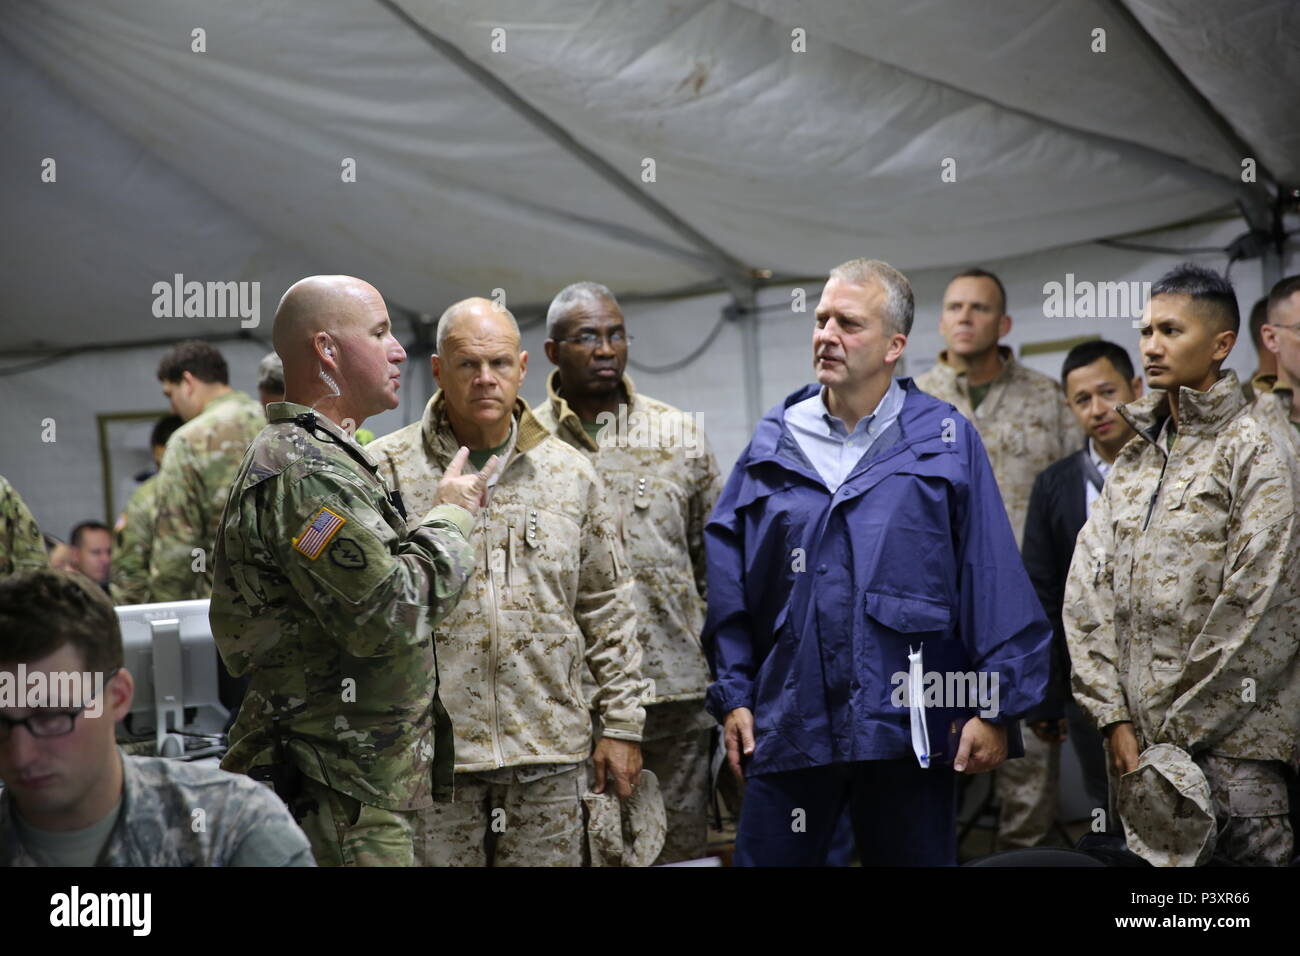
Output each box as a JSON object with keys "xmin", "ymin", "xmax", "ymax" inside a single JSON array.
[{"xmin": 0, "ymin": 568, "xmax": 315, "ymax": 866}]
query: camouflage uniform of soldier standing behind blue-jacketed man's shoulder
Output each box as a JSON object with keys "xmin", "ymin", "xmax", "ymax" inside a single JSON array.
[{"xmin": 917, "ymin": 346, "xmax": 1084, "ymax": 849}]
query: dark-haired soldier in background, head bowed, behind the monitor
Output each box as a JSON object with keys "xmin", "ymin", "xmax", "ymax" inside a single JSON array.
[{"xmin": 147, "ymin": 341, "xmax": 267, "ymax": 602}]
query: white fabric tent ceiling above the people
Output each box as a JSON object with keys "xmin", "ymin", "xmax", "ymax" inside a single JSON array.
[{"xmin": 0, "ymin": 0, "xmax": 1300, "ymax": 352}]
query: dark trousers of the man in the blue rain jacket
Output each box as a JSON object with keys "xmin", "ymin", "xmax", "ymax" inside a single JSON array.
[{"xmin": 733, "ymin": 758, "xmax": 957, "ymax": 866}]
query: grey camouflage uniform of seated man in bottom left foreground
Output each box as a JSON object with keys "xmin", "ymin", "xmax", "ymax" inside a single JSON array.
[{"xmin": 0, "ymin": 753, "xmax": 313, "ymax": 866}]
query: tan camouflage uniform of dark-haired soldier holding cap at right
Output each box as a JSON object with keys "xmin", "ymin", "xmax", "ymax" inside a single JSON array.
[{"xmin": 1063, "ymin": 372, "xmax": 1300, "ymax": 862}]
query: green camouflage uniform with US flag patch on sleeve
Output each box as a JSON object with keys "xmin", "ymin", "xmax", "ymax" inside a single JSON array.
[{"xmin": 211, "ymin": 402, "xmax": 473, "ymax": 865}]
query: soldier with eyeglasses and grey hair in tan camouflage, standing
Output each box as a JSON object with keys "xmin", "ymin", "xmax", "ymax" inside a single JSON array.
[{"xmin": 536, "ymin": 282, "xmax": 722, "ymax": 864}]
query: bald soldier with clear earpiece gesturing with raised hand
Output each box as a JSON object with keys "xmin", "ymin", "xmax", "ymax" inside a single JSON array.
[{"xmin": 211, "ymin": 276, "xmax": 494, "ymax": 866}]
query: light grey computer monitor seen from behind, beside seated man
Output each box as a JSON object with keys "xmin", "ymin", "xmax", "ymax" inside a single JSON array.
[{"xmin": 116, "ymin": 601, "xmax": 230, "ymax": 757}]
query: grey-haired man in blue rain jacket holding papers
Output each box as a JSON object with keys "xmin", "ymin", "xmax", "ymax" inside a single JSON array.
[{"xmin": 705, "ymin": 259, "xmax": 1052, "ymax": 866}]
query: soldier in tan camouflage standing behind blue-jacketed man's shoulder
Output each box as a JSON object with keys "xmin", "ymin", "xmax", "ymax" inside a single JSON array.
[{"xmin": 917, "ymin": 269, "xmax": 1084, "ymax": 849}]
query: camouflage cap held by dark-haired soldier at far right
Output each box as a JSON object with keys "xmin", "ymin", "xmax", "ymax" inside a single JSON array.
[{"xmin": 1117, "ymin": 744, "xmax": 1217, "ymax": 866}]
